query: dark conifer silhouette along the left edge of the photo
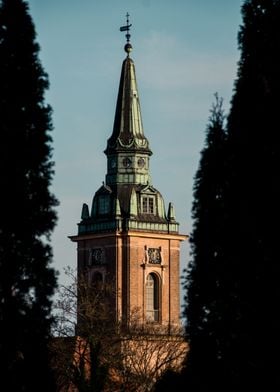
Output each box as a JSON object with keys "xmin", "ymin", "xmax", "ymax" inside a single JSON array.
[{"xmin": 0, "ymin": 0, "xmax": 57, "ymax": 392}]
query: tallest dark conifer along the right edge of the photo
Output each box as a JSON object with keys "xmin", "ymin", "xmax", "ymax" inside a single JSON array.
[{"xmin": 225, "ymin": 0, "xmax": 280, "ymax": 390}]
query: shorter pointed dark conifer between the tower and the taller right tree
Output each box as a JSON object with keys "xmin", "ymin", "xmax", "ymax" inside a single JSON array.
[{"xmin": 182, "ymin": 94, "xmax": 228, "ymax": 391}]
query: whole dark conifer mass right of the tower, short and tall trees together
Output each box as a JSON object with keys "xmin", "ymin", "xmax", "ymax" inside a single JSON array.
[{"xmin": 182, "ymin": 0, "xmax": 280, "ymax": 391}]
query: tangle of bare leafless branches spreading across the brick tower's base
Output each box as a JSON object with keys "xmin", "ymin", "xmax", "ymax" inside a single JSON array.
[{"xmin": 52, "ymin": 268, "xmax": 187, "ymax": 392}]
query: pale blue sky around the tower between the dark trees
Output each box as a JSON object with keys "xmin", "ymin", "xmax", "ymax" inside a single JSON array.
[{"xmin": 29, "ymin": 0, "xmax": 242, "ymax": 298}]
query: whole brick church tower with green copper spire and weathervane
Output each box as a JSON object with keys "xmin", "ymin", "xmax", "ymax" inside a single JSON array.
[{"xmin": 70, "ymin": 19, "xmax": 187, "ymax": 327}]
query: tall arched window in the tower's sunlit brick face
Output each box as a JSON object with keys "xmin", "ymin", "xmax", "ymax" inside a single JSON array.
[{"xmin": 146, "ymin": 273, "xmax": 159, "ymax": 322}]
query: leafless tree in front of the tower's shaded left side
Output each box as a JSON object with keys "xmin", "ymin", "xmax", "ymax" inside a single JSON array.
[{"xmin": 51, "ymin": 267, "xmax": 114, "ymax": 392}]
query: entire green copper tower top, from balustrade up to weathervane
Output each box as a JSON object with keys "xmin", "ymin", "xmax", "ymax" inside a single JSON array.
[{"xmin": 75, "ymin": 15, "xmax": 183, "ymax": 233}]
